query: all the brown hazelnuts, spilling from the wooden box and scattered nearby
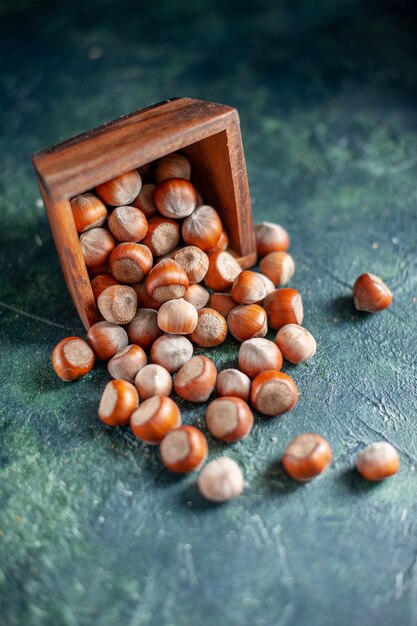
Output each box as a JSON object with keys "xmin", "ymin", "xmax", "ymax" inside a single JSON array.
[{"xmin": 52, "ymin": 153, "xmax": 399, "ymax": 502}]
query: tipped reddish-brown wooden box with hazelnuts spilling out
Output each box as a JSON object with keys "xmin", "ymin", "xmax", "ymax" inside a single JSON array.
[{"xmin": 32, "ymin": 98, "xmax": 256, "ymax": 329}]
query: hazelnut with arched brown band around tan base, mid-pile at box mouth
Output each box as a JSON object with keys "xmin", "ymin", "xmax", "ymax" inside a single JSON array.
[{"xmin": 145, "ymin": 258, "xmax": 189, "ymax": 302}]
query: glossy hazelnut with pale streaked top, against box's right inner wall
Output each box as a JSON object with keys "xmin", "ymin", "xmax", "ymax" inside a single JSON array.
[{"xmin": 181, "ymin": 204, "xmax": 223, "ymax": 251}]
